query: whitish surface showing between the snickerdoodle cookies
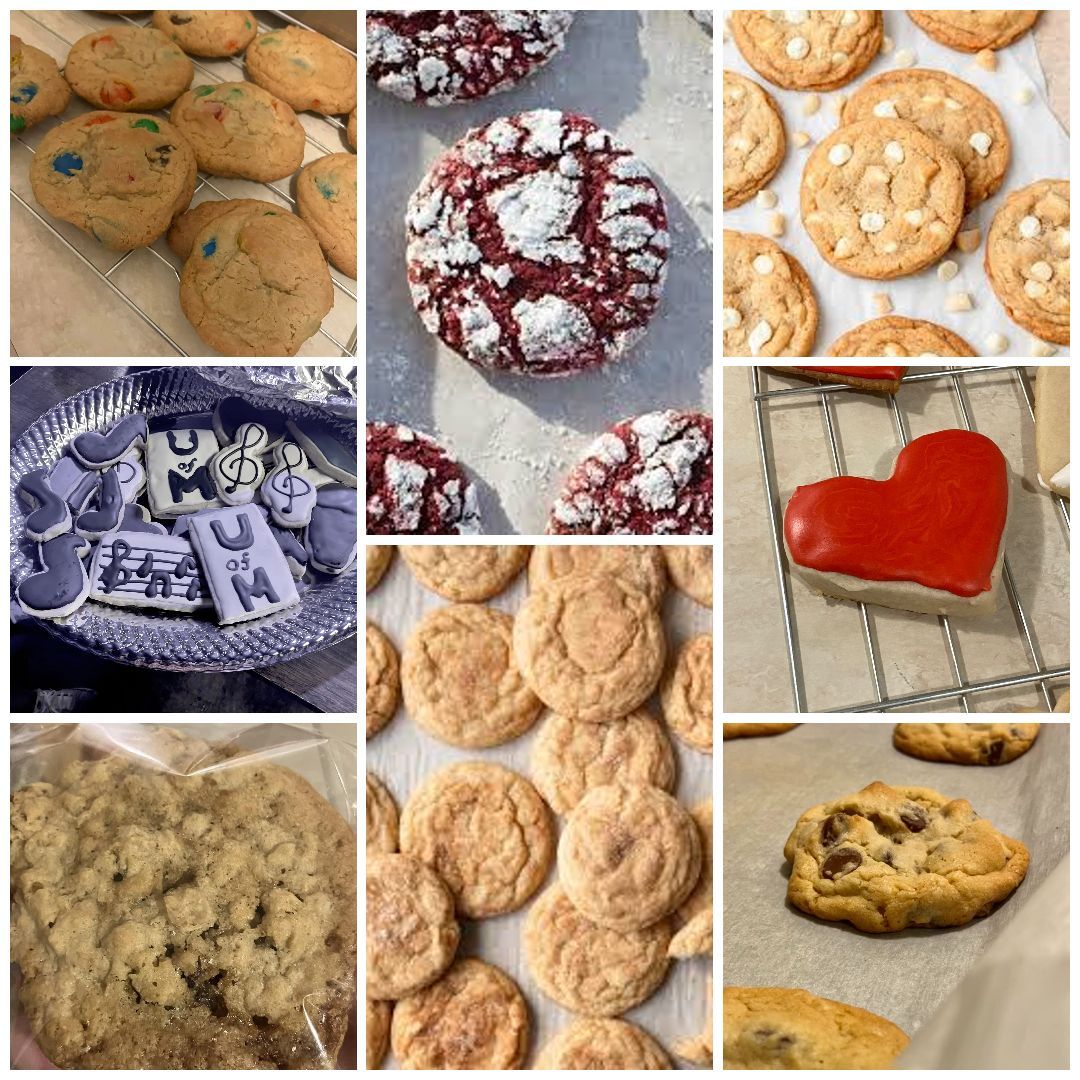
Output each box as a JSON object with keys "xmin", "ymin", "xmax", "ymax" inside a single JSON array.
[{"xmin": 365, "ymin": 544, "xmax": 715, "ymax": 1069}]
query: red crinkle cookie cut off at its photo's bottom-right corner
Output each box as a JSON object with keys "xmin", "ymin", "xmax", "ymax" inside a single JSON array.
[{"xmin": 548, "ymin": 409, "xmax": 713, "ymax": 535}]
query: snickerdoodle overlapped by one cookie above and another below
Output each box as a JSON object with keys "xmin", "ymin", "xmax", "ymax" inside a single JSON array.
[{"xmin": 532, "ymin": 710, "xmax": 675, "ymax": 814}]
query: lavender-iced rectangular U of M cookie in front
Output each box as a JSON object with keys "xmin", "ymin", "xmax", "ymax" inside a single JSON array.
[{"xmin": 188, "ymin": 503, "xmax": 300, "ymax": 625}]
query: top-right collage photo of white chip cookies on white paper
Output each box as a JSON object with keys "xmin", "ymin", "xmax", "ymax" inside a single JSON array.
[{"xmin": 723, "ymin": 8, "xmax": 1071, "ymax": 359}]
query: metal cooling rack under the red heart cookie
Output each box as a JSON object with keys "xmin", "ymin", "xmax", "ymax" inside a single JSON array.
[{"xmin": 751, "ymin": 364, "xmax": 1070, "ymax": 713}]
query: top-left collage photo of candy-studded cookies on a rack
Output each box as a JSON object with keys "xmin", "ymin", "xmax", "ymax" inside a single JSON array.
[{"xmin": 10, "ymin": 8, "xmax": 359, "ymax": 361}]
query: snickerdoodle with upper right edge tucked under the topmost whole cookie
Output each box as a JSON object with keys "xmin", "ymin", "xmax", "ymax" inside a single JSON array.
[{"xmin": 402, "ymin": 604, "xmax": 542, "ymax": 748}]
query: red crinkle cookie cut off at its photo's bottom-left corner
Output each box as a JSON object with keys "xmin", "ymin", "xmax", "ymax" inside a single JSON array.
[{"xmin": 367, "ymin": 423, "xmax": 480, "ymax": 536}]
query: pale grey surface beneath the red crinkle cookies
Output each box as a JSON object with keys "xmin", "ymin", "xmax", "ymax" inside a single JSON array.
[{"xmin": 365, "ymin": 11, "xmax": 713, "ymax": 534}]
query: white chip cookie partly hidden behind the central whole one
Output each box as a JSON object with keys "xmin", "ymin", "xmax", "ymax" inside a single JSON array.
[{"xmin": 841, "ymin": 68, "xmax": 1010, "ymax": 210}]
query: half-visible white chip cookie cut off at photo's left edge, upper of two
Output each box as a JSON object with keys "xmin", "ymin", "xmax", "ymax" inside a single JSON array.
[{"xmin": 724, "ymin": 71, "xmax": 787, "ymax": 210}]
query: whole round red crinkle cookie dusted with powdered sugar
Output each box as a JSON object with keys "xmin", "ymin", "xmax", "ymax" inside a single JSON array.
[{"xmin": 406, "ymin": 109, "xmax": 669, "ymax": 376}]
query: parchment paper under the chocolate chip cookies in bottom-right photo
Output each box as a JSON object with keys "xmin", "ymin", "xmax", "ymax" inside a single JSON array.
[{"xmin": 723, "ymin": 721, "xmax": 1069, "ymax": 1037}]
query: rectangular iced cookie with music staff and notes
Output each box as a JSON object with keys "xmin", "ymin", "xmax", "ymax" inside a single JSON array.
[{"xmin": 90, "ymin": 530, "xmax": 212, "ymax": 611}]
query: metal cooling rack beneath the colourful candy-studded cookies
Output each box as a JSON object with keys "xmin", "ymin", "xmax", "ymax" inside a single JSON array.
[{"xmin": 12, "ymin": 11, "xmax": 356, "ymax": 357}]
